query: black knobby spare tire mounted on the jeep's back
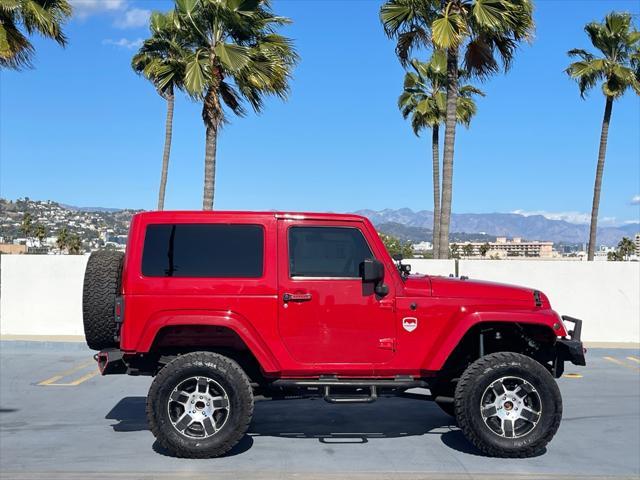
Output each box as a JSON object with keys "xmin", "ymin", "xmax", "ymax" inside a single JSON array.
[{"xmin": 82, "ymin": 250, "xmax": 124, "ymax": 350}]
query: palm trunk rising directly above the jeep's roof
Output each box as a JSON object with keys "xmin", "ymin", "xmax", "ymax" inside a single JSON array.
[{"xmin": 202, "ymin": 86, "xmax": 222, "ymax": 210}]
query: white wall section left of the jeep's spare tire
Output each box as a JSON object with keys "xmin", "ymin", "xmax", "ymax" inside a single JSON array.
[{"xmin": 0, "ymin": 255, "xmax": 89, "ymax": 335}]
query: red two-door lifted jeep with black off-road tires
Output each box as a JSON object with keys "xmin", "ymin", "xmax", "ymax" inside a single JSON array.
[{"xmin": 83, "ymin": 212, "xmax": 585, "ymax": 457}]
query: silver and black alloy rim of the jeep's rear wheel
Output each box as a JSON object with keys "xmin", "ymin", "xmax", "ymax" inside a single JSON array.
[{"xmin": 167, "ymin": 377, "xmax": 230, "ymax": 438}]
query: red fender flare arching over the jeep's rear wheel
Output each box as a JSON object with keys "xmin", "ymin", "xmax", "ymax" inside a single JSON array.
[{"xmin": 136, "ymin": 310, "xmax": 280, "ymax": 372}]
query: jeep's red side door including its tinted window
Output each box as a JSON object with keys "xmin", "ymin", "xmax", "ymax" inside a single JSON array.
[{"xmin": 278, "ymin": 219, "xmax": 395, "ymax": 364}]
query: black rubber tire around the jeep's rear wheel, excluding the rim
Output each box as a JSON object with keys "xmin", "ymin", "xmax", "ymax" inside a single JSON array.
[{"xmin": 146, "ymin": 352, "xmax": 253, "ymax": 458}]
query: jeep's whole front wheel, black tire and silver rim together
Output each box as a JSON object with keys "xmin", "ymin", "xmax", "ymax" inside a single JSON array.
[{"xmin": 455, "ymin": 352, "xmax": 562, "ymax": 457}]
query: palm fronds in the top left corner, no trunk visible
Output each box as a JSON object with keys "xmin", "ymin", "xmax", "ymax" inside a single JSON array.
[{"xmin": 0, "ymin": 0, "xmax": 71, "ymax": 70}]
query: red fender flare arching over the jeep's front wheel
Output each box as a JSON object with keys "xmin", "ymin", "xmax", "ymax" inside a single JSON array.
[{"xmin": 423, "ymin": 309, "xmax": 567, "ymax": 371}]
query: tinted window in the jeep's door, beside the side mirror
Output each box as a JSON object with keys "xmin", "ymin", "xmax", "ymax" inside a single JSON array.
[{"xmin": 289, "ymin": 227, "xmax": 373, "ymax": 278}]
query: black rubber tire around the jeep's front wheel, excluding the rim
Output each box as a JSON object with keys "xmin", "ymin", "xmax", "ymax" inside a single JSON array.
[{"xmin": 455, "ymin": 352, "xmax": 562, "ymax": 458}]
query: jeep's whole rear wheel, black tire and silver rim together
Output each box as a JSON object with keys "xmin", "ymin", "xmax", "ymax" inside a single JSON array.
[{"xmin": 147, "ymin": 352, "xmax": 253, "ymax": 458}]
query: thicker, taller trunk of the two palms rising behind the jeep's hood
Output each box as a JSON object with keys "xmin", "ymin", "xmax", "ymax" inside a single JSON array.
[{"xmin": 439, "ymin": 48, "xmax": 458, "ymax": 258}]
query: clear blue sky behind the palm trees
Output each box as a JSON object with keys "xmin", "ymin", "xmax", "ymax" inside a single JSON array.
[{"xmin": 0, "ymin": 0, "xmax": 640, "ymax": 225}]
